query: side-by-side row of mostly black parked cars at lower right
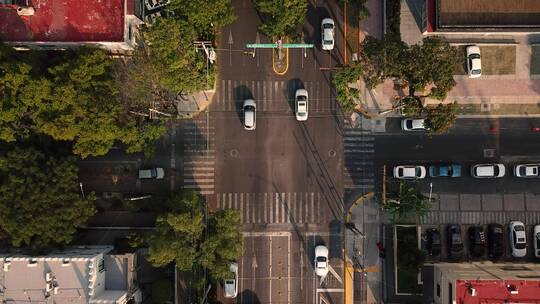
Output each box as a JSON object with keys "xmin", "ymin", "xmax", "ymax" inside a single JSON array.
[{"xmin": 426, "ymin": 221, "xmax": 540, "ymax": 260}]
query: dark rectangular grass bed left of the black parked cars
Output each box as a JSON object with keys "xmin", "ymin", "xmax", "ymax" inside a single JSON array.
[{"xmin": 395, "ymin": 226, "xmax": 422, "ymax": 294}]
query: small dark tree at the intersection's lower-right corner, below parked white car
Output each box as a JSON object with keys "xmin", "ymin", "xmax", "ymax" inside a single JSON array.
[{"xmin": 382, "ymin": 182, "xmax": 431, "ymax": 222}]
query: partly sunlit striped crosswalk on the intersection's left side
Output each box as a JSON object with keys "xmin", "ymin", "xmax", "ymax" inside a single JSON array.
[{"xmin": 182, "ymin": 114, "xmax": 215, "ymax": 195}]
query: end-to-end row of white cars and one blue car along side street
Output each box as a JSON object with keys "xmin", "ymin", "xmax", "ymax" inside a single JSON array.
[{"xmin": 394, "ymin": 163, "xmax": 540, "ymax": 179}]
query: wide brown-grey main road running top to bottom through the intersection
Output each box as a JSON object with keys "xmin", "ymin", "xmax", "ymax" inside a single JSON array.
[{"xmin": 207, "ymin": 0, "xmax": 344, "ymax": 303}]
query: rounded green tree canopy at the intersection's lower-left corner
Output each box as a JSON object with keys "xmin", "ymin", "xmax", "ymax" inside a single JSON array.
[{"xmin": 147, "ymin": 191, "xmax": 243, "ymax": 280}]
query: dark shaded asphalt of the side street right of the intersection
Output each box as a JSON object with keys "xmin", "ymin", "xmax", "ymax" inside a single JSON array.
[{"xmin": 375, "ymin": 118, "xmax": 540, "ymax": 193}]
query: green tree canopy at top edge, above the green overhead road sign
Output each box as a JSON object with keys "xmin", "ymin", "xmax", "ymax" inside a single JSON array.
[{"xmin": 255, "ymin": 0, "xmax": 307, "ymax": 38}]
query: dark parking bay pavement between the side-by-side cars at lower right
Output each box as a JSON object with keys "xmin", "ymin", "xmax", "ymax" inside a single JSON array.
[{"xmin": 420, "ymin": 223, "xmax": 538, "ymax": 263}]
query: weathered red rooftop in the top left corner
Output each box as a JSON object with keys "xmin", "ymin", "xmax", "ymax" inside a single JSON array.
[{"xmin": 0, "ymin": 0, "xmax": 125, "ymax": 42}]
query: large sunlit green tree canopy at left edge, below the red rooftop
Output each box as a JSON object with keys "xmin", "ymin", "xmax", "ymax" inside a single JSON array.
[{"xmin": 0, "ymin": 47, "xmax": 165, "ymax": 157}]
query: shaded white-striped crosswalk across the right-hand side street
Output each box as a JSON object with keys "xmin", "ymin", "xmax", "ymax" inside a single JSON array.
[{"xmin": 343, "ymin": 124, "xmax": 375, "ymax": 192}]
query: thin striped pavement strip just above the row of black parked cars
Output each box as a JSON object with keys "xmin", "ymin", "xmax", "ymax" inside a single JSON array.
[{"xmin": 420, "ymin": 210, "xmax": 540, "ymax": 225}]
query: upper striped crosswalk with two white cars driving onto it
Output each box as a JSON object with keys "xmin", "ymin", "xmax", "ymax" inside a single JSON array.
[{"xmin": 211, "ymin": 79, "xmax": 338, "ymax": 113}]
